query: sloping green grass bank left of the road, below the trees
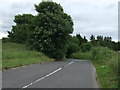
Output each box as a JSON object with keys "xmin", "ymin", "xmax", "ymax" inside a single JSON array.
[{"xmin": 2, "ymin": 42, "xmax": 54, "ymax": 69}]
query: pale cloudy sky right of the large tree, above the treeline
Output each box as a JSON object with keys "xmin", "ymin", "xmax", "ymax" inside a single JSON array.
[{"xmin": 59, "ymin": 2, "xmax": 118, "ymax": 40}]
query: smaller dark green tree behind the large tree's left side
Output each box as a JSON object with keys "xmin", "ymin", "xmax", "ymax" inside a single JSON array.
[{"xmin": 8, "ymin": 14, "xmax": 34, "ymax": 43}]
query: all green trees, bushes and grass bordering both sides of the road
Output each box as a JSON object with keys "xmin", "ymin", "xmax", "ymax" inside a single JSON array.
[{"xmin": 2, "ymin": 2, "xmax": 120, "ymax": 88}]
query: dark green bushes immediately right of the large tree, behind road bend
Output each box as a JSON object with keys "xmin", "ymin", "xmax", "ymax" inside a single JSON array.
[{"xmin": 66, "ymin": 34, "xmax": 89, "ymax": 57}]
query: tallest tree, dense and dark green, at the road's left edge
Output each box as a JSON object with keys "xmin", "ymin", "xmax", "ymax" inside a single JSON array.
[{"xmin": 30, "ymin": 2, "xmax": 73, "ymax": 60}]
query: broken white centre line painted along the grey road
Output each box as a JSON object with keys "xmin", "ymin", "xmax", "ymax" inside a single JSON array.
[{"xmin": 22, "ymin": 61, "xmax": 73, "ymax": 89}]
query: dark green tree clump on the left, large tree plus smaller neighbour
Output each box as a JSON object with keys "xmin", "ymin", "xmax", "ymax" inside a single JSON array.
[{"xmin": 8, "ymin": 2, "xmax": 73, "ymax": 60}]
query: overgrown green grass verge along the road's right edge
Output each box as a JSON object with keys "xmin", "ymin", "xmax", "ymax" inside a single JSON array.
[{"xmin": 71, "ymin": 47, "xmax": 118, "ymax": 88}]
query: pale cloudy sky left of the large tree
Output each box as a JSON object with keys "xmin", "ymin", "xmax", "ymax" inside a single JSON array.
[{"xmin": 0, "ymin": 2, "xmax": 36, "ymax": 34}]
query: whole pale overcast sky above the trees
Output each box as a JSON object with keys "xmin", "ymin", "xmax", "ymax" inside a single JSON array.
[{"xmin": 0, "ymin": 0, "xmax": 118, "ymax": 41}]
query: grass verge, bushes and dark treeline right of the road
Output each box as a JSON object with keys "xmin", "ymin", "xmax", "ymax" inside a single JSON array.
[{"xmin": 67, "ymin": 34, "xmax": 120, "ymax": 88}]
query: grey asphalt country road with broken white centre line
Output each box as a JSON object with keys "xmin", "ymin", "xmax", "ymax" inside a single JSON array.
[{"xmin": 2, "ymin": 59, "xmax": 98, "ymax": 89}]
